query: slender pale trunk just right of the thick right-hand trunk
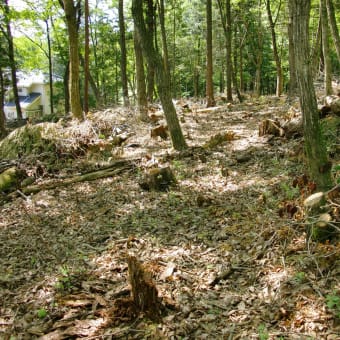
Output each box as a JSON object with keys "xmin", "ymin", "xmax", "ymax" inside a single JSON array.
[{"xmin": 320, "ymin": 0, "xmax": 333, "ymax": 96}]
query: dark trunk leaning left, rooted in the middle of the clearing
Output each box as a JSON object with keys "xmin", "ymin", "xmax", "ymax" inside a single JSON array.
[{"xmin": 132, "ymin": 0, "xmax": 187, "ymax": 150}]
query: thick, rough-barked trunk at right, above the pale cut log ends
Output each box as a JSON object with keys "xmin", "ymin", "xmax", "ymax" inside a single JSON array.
[{"xmin": 288, "ymin": 0, "xmax": 332, "ymax": 191}]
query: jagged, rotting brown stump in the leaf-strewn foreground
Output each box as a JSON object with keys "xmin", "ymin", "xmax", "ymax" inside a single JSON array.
[{"xmin": 128, "ymin": 256, "xmax": 163, "ymax": 321}]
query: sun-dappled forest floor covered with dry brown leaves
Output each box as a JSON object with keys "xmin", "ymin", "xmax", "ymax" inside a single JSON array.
[{"xmin": 0, "ymin": 97, "xmax": 340, "ymax": 340}]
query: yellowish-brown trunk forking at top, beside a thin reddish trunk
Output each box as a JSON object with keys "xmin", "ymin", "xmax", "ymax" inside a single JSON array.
[{"xmin": 63, "ymin": 0, "xmax": 83, "ymax": 120}]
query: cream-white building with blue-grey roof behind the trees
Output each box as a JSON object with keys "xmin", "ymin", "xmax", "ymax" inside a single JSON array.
[{"xmin": 4, "ymin": 73, "xmax": 51, "ymax": 120}]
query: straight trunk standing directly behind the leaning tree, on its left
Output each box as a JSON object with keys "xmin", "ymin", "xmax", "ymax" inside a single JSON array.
[{"xmin": 133, "ymin": 29, "xmax": 148, "ymax": 121}]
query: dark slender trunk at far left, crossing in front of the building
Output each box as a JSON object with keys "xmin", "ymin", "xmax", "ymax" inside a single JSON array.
[{"xmin": 4, "ymin": 0, "xmax": 23, "ymax": 120}]
